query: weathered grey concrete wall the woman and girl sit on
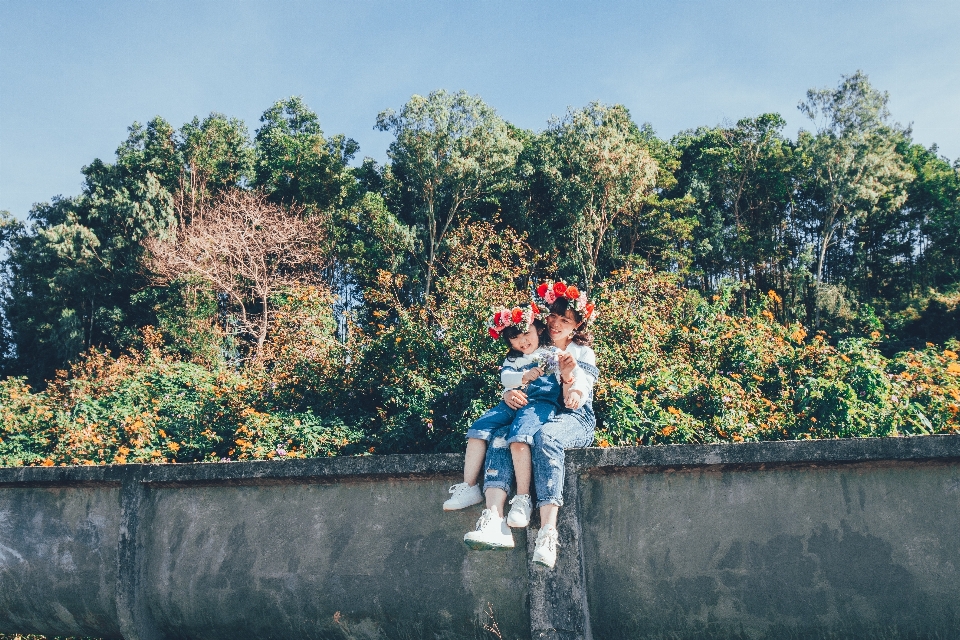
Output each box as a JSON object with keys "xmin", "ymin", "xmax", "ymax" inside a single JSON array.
[{"xmin": 0, "ymin": 436, "xmax": 960, "ymax": 640}]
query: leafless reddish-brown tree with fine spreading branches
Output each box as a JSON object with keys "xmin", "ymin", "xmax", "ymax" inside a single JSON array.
[{"xmin": 145, "ymin": 190, "xmax": 329, "ymax": 361}]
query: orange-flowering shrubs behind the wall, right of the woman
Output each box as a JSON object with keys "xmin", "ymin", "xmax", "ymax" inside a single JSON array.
[{"xmin": 596, "ymin": 270, "xmax": 960, "ymax": 445}]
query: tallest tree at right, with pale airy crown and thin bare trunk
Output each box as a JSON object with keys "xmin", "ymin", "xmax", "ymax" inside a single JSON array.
[{"xmin": 798, "ymin": 71, "xmax": 913, "ymax": 326}]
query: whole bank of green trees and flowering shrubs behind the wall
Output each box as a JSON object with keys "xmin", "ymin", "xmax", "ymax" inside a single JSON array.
[{"xmin": 0, "ymin": 72, "xmax": 960, "ymax": 465}]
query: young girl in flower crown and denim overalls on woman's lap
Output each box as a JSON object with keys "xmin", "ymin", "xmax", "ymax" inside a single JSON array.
[{"xmin": 443, "ymin": 304, "xmax": 560, "ymax": 549}]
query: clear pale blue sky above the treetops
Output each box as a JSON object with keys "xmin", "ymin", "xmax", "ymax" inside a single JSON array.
[{"xmin": 0, "ymin": 0, "xmax": 960, "ymax": 218}]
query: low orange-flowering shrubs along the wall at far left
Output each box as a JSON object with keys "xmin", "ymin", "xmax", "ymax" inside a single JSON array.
[{"xmin": 0, "ymin": 328, "xmax": 358, "ymax": 466}]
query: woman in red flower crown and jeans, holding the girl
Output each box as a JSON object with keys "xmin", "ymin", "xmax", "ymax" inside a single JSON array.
[{"xmin": 465, "ymin": 282, "xmax": 599, "ymax": 568}]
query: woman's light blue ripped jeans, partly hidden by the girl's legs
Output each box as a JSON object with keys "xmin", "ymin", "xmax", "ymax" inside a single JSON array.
[{"xmin": 483, "ymin": 404, "xmax": 597, "ymax": 507}]
